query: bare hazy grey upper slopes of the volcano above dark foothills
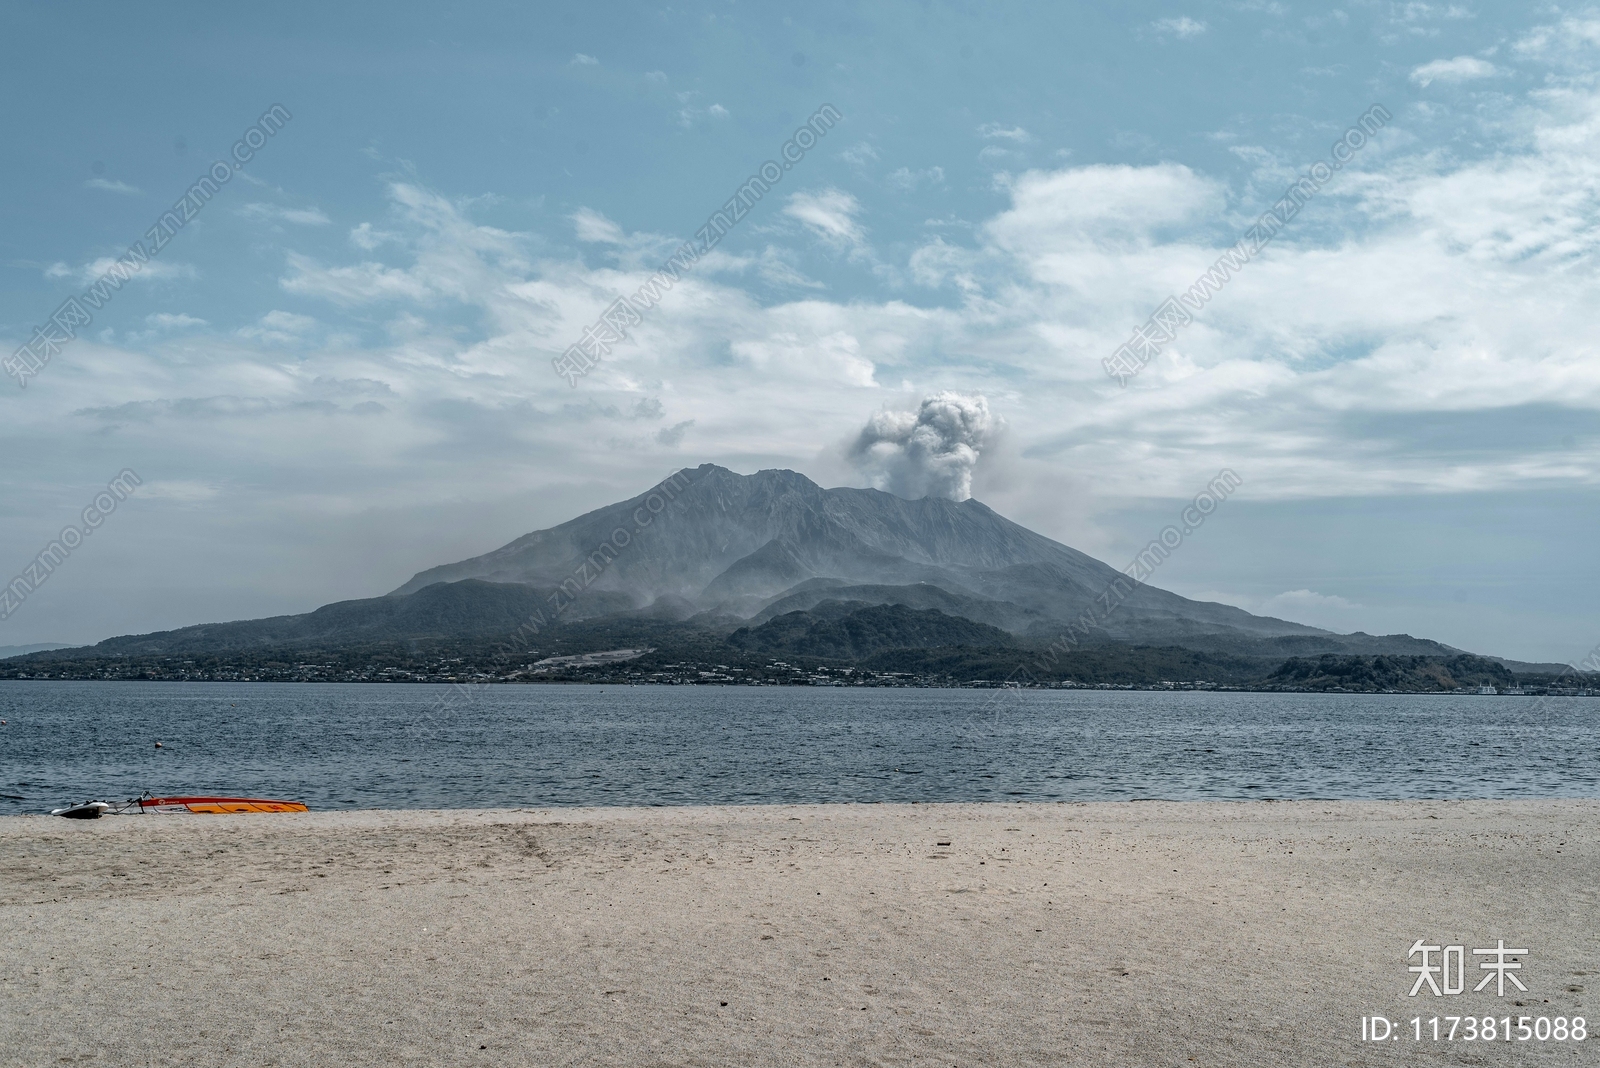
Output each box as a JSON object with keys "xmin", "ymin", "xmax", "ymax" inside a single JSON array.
[{"xmin": 395, "ymin": 464, "xmax": 1328, "ymax": 640}]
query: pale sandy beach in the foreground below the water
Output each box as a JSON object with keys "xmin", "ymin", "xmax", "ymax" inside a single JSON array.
[{"xmin": 0, "ymin": 801, "xmax": 1600, "ymax": 1066}]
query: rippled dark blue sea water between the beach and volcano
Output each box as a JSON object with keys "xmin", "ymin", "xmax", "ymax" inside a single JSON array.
[{"xmin": 0, "ymin": 681, "xmax": 1600, "ymax": 814}]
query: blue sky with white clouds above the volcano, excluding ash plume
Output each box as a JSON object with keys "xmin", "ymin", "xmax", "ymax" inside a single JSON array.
[{"xmin": 0, "ymin": 0, "xmax": 1600, "ymax": 660}]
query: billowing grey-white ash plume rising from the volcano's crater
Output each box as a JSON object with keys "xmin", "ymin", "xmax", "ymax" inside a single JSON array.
[{"xmin": 850, "ymin": 390, "xmax": 994, "ymax": 500}]
